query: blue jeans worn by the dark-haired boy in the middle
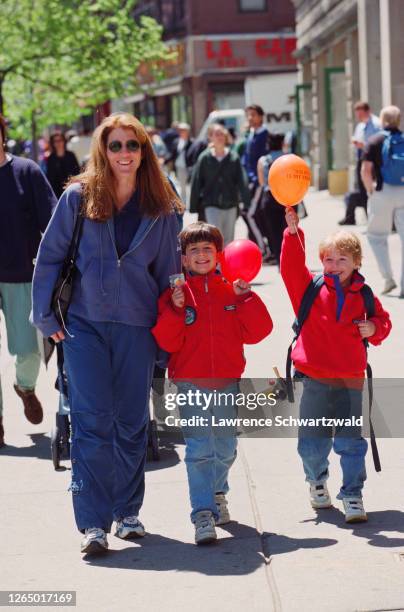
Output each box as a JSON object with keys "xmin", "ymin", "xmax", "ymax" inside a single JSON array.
[{"xmin": 178, "ymin": 383, "xmax": 238, "ymax": 521}]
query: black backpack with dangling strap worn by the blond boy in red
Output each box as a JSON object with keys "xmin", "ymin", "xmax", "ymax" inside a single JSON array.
[{"xmin": 286, "ymin": 274, "xmax": 381, "ymax": 472}]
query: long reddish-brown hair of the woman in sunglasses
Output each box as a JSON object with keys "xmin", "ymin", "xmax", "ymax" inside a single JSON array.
[{"xmin": 69, "ymin": 113, "xmax": 184, "ymax": 221}]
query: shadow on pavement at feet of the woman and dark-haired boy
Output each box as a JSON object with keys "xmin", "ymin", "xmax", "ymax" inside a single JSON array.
[{"xmin": 83, "ymin": 523, "xmax": 265, "ymax": 576}]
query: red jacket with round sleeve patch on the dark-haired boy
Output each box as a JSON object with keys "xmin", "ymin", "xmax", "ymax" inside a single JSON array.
[{"xmin": 152, "ymin": 272, "xmax": 273, "ymax": 379}]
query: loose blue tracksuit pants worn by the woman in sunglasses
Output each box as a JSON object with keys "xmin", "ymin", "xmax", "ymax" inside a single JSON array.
[{"xmin": 63, "ymin": 315, "xmax": 156, "ymax": 532}]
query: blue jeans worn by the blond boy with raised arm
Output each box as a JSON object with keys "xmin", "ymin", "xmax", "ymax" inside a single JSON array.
[{"xmin": 298, "ymin": 376, "xmax": 368, "ymax": 499}]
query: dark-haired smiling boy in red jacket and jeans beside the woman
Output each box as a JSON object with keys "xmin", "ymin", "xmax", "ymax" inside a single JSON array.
[{"xmin": 152, "ymin": 222, "xmax": 273, "ymax": 544}]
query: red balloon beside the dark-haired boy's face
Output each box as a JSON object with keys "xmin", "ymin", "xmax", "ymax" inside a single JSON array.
[{"xmin": 221, "ymin": 240, "xmax": 262, "ymax": 283}]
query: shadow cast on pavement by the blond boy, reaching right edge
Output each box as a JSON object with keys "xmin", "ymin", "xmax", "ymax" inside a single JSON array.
[{"xmin": 303, "ymin": 508, "xmax": 404, "ymax": 548}]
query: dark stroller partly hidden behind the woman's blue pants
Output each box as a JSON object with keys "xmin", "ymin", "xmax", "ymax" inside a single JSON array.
[{"xmin": 49, "ymin": 343, "xmax": 160, "ymax": 470}]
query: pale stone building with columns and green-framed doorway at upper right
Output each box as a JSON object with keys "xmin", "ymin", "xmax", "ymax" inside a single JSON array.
[{"xmin": 293, "ymin": 0, "xmax": 404, "ymax": 193}]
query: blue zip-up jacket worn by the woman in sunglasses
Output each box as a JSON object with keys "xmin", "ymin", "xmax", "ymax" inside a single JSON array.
[{"xmin": 31, "ymin": 184, "xmax": 181, "ymax": 336}]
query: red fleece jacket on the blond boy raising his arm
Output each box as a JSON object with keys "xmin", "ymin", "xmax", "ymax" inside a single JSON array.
[{"xmin": 281, "ymin": 228, "xmax": 391, "ymax": 378}]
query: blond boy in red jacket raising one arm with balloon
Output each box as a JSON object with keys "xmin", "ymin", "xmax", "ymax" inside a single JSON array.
[{"xmin": 281, "ymin": 208, "xmax": 391, "ymax": 523}]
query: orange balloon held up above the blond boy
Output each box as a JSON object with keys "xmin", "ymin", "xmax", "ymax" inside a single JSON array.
[{"xmin": 268, "ymin": 153, "xmax": 311, "ymax": 206}]
